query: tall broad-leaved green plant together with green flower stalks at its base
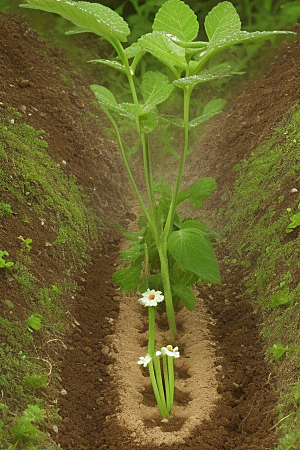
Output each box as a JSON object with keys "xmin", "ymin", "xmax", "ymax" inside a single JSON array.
[{"xmin": 21, "ymin": 0, "xmax": 296, "ymax": 416}]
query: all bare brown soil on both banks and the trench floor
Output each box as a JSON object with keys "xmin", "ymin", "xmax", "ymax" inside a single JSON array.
[{"xmin": 0, "ymin": 10, "xmax": 300, "ymax": 450}]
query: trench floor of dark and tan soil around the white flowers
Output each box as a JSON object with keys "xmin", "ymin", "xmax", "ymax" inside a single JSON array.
[{"xmin": 53, "ymin": 243, "xmax": 276, "ymax": 450}]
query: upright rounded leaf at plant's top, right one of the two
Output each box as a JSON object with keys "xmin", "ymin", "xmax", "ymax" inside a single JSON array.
[{"xmin": 204, "ymin": 2, "xmax": 241, "ymax": 43}]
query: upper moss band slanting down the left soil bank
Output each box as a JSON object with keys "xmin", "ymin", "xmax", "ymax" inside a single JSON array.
[{"xmin": 0, "ymin": 107, "xmax": 99, "ymax": 264}]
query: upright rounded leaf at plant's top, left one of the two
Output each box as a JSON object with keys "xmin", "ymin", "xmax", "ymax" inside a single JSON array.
[{"xmin": 152, "ymin": 0, "xmax": 199, "ymax": 41}]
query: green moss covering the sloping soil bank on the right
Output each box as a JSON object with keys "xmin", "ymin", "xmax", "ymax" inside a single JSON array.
[{"xmin": 221, "ymin": 105, "xmax": 300, "ymax": 450}]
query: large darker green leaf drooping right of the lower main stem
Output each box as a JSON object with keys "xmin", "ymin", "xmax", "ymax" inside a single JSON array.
[{"xmin": 168, "ymin": 228, "xmax": 221, "ymax": 284}]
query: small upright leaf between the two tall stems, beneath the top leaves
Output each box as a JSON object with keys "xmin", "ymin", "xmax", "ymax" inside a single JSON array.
[{"xmin": 141, "ymin": 71, "xmax": 174, "ymax": 112}]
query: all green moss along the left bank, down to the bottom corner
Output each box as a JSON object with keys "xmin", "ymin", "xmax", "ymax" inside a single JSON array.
[{"xmin": 0, "ymin": 109, "xmax": 100, "ymax": 450}]
